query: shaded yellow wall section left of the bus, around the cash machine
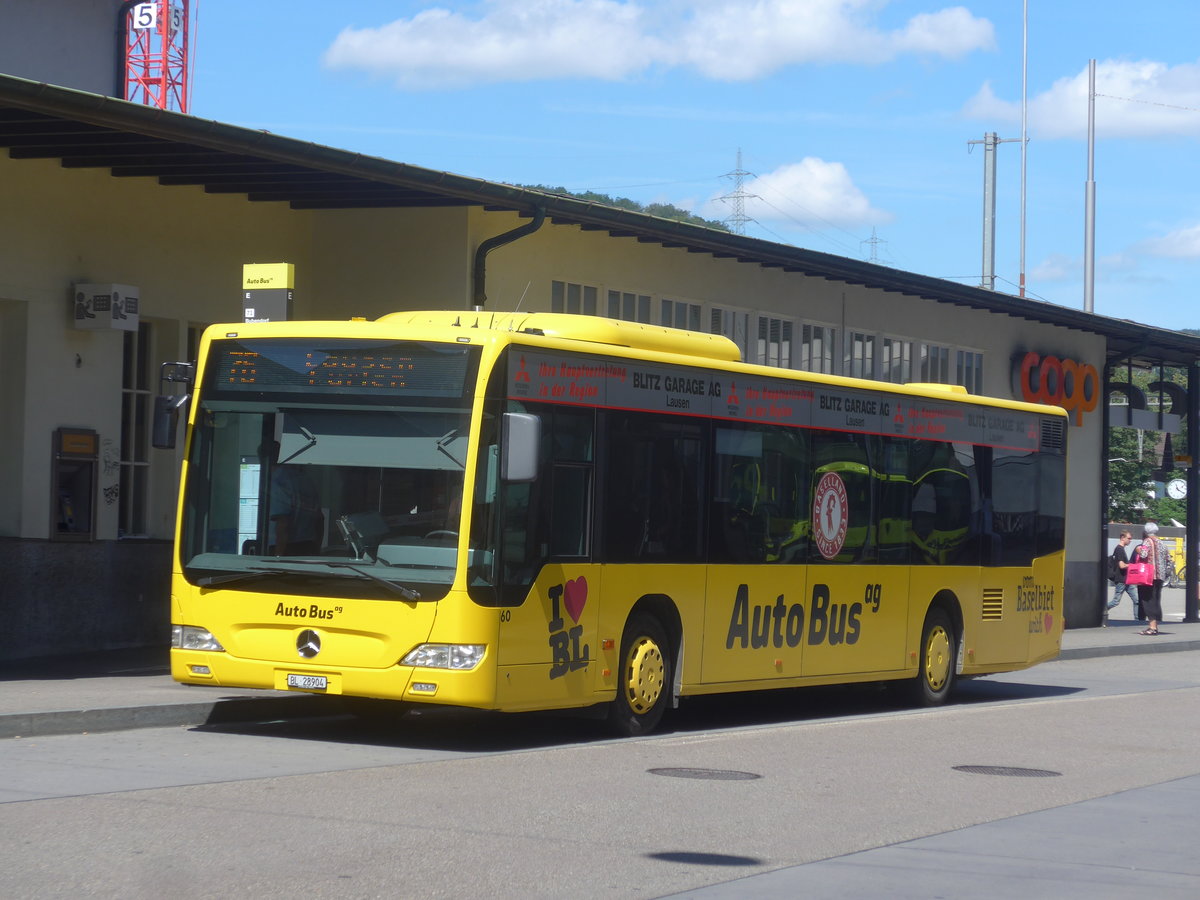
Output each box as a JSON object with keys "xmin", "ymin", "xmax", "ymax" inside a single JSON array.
[{"xmin": 0, "ymin": 157, "xmax": 312, "ymax": 540}]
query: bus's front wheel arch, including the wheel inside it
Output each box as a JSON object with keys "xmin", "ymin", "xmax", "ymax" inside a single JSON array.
[{"xmin": 608, "ymin": 595, "xmax": 683, "ymax": 737}]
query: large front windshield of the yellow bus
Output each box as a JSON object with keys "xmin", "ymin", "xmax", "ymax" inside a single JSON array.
[{"xmin": 180, "ymin": 340, "xmax": 473, "ymax": 600}]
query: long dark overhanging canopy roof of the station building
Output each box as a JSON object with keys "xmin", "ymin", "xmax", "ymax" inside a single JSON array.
[{"xmin": 0, "ymin": 76, "xmax": 1200, "ymax": 366}]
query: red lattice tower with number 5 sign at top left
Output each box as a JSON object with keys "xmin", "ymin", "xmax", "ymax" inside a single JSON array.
[{"xmin": 121, "ymin": 0, "xmax": 190, "ymax": 113}]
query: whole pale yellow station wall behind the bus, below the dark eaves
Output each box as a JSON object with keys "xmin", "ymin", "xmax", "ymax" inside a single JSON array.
[{"xmin": 0, "ymin": 150, "xmax": 1104, "ymax": 578}]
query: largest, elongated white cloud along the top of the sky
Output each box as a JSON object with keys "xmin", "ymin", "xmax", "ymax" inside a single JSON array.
[{"xmin": 324, "ymin": 0, "xmax": 995, "ymax": 89}]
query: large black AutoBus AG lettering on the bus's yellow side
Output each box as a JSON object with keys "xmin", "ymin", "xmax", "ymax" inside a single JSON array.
[{"xmin": 725, "ymin": 583, "xmax": 883, "ymax": 650}]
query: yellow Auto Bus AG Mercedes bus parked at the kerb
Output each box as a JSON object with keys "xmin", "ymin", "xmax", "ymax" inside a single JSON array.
[{"xmin": 155, "ymin": 312, "xmax": 1067, "ymax": 734}]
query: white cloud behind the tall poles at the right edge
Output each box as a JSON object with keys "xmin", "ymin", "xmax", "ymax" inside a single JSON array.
[{"xmin": 962, "ymin": 60, "xmax": 1200, "ymax": 138}]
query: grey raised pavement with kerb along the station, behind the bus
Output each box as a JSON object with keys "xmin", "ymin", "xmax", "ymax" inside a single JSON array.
[{"xmin": 0, "ymin": 588, "xmax": 1200, "ymax": 738}]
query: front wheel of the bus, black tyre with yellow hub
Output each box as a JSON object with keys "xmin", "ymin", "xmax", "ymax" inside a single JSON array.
[{"xmin": 608, "ymin": 613, "xmax": 672, "ymax": 737}]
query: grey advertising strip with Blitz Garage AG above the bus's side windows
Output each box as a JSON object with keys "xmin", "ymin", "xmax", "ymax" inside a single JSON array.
[{"xmin": 508, "ymin": 347, "xmax": 1040, "ymax": 450}]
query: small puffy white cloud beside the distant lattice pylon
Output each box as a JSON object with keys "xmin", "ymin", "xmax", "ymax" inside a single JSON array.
[{"xmin": 703, "ymin": 156, "xmax": 892, "ymax": 229}]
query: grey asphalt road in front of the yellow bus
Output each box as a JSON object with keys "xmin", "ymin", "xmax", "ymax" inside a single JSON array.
[{"xmin": 0, "ymin": 652, "xmax": 1200, "ymax": 900}]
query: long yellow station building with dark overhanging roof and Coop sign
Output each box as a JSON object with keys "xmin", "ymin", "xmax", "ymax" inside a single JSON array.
[{"xmin": 0, "ymin": 22, "xmax": 1200, "ymax": 660}]
